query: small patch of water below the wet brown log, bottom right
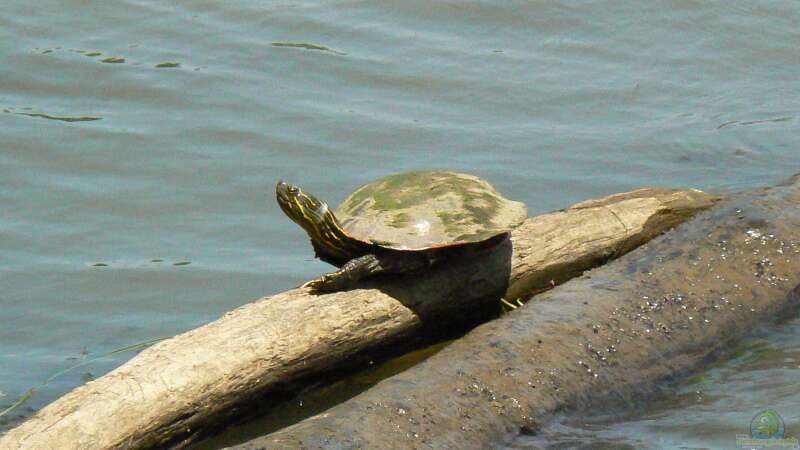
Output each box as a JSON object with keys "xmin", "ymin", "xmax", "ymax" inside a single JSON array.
[{"xmin": 506, "ymin": 318, "xmax": 800, "ymax": 450}]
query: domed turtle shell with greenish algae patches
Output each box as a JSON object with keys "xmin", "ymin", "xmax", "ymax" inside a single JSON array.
[{"xmin": 335, "ymin": 172, "xmax": 528, "ymax": 250}]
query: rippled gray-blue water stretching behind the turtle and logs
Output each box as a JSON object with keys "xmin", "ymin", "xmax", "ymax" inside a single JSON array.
[{"xmin": 0, "ymin": 0, "xmax": 800, "ymax": 445}]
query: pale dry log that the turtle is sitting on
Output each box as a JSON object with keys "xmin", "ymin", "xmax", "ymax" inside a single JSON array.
[{"xmin": 0, "ymin": 189, "xmax": 718, "ymax": 449}]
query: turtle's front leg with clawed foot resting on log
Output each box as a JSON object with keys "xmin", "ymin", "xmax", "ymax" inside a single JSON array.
[{"xmin": 303, "ymin": 254, "xmax": 429, "ymax": 292}]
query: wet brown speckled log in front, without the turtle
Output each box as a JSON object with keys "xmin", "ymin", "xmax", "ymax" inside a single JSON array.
[{"xmin": 241, "ymin": 175, "xmax": 800, "ymax": 450}]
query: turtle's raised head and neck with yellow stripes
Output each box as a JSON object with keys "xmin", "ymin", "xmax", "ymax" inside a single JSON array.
[{"xmin": 275, "ymin": 181, "xmax": 355, "ymax": 259}]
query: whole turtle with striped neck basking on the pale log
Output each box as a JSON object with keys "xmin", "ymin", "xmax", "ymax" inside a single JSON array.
[{"xmin": 275, "ymin": 171, "xmax": 527, "ymax": 292}]
